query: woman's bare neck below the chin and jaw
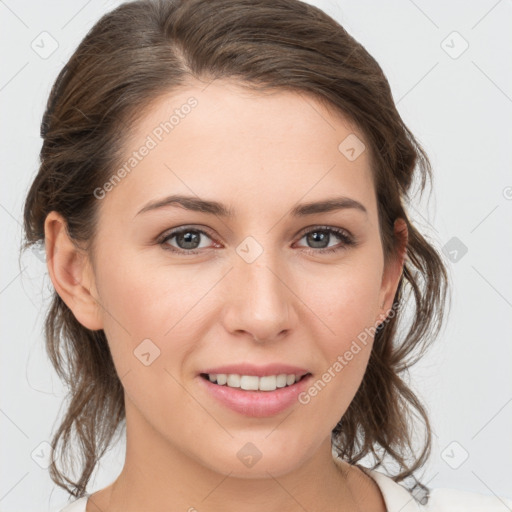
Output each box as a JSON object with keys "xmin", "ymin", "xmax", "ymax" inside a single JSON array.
[{"xmin": 87, "ymin": 400, "xmax": 359, "ymax": 512}]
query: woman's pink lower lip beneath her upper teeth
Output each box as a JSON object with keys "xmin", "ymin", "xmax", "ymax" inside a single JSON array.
[{"xmin": 198, "ymin": 374, "xmax": 312, "ymax": 418}]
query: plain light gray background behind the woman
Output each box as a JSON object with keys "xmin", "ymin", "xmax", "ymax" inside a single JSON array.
[{"xmin": 0, "ymin": 0, "xmax": 512, "ymax": 512}]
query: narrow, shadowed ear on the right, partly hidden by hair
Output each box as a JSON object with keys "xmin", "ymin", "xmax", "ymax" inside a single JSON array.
[{"xmin": 376, "ymin": 218, "xmax": 409, "ymax": 323}]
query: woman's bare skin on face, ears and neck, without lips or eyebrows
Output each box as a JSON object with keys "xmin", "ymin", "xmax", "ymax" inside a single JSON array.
[{"xmin": 45, "ymin": 81, "xmax": 407, "ymax": 512}]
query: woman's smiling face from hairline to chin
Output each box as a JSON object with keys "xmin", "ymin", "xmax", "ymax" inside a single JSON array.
[{"xmin": 80, "ymin": 81, "xmax": 400, "ymax": 477}]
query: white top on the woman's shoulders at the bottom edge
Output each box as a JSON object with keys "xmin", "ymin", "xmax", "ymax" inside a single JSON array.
[{"xmin": 59, "ymin": 457, "xmax": 512, "ymax": 512}]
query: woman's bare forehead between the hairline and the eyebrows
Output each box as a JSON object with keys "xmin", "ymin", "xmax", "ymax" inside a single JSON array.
[{"xmin": 102, "ymin": 80, "xmax": 374, "ymax": 222}]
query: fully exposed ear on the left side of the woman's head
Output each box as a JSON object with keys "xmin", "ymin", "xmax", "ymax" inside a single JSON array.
[{"xmin": 44, "ymin": 211, "xmax": 103, "ymax": 330}]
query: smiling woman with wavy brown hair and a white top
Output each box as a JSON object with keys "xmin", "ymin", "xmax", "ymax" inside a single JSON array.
[{"xmin": 25, "ymin": 0, "xmax": 505, "ymax": 512}]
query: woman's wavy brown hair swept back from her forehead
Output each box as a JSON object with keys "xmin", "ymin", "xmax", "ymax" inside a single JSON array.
[{"xmin": 24, "ymin": 0, "xmax": 448, "ymax": 502}]
